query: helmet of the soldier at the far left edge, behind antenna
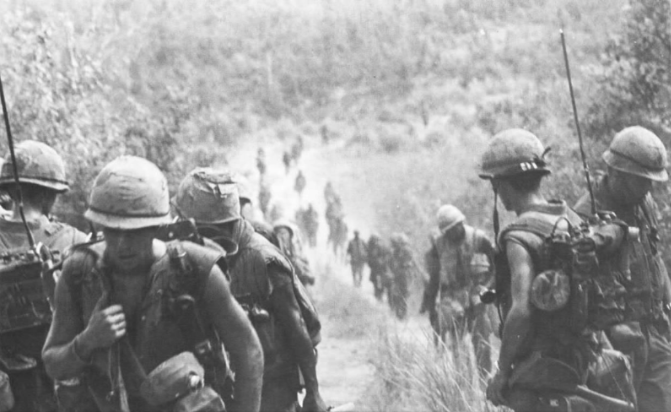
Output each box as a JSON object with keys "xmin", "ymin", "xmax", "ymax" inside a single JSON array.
[{"xmin": 0, "ymin": 140, "xmax": 69, "ymax": 193}]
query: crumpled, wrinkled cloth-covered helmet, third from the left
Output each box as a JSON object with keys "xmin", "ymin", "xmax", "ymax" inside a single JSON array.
[{"xmin": 172, "ymin": 167, "xmax": 241, "ymax": 224}]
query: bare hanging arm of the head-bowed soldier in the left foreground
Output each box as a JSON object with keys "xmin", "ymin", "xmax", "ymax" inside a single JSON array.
[{"xmin": 203, "ymin": 266, "xmax": 263, "ymax": 411}]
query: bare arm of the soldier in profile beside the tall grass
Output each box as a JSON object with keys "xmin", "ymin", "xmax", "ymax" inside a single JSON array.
[{"xmin": 499, "ymin": 242, "xmax": 534, "ymax": 377}]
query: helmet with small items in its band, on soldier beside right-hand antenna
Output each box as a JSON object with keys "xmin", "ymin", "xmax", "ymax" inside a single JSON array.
[{"xmin": 479, "ymin": 129, "xmax": 550, "ymax": 179}]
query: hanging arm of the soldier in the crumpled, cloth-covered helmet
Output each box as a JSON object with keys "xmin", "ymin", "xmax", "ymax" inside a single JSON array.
[{"xmin": 268, "ymin": 267, "xmax": 323, "ymax": 410}]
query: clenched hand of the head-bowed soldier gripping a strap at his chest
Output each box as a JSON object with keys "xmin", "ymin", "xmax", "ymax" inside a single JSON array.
[{"xmin": 80, "ymin": 293, "xmax": 126, "ymax": 350}]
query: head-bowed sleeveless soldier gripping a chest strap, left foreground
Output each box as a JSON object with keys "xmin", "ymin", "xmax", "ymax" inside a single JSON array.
[{"xmin": 43, "ymin": 156, "xmax": 263, "ymax": 412}]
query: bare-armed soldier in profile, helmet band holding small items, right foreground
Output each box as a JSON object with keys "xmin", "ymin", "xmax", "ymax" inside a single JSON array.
[{"xmin": 480, "ymin": 129, "xmax": 597, "ymax": 412}]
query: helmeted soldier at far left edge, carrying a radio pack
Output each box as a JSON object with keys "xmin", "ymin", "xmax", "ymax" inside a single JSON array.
[{"xmin": 0, "ymin": 140, "xmax": 86, "ymax": 411}]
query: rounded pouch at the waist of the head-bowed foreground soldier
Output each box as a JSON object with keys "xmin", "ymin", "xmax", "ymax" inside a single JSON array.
[{"xmin": 140, "ymin": 352, "xmax": 226, "ymax": 412}]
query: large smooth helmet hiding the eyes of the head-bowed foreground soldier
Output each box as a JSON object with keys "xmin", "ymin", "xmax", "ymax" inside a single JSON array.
[{"xmin": 84, "ymin": 156, "xmax": 171, "ymax": 230}]
